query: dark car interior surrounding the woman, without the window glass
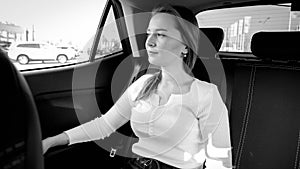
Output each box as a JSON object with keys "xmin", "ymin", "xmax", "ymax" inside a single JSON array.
[{"xmin": 0, "ymin": 0, "xmax": 300, "ymax": 169}]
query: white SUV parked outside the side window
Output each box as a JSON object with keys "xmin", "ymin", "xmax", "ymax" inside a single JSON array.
[{"xmin": 8, "ymin": 42, "xmax": 75, "ymax": 64}]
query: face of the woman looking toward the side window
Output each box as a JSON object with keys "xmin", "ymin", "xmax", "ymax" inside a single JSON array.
[{"xmin": 145, "ymin": 13, "xmax": 187, "ymax": 67}]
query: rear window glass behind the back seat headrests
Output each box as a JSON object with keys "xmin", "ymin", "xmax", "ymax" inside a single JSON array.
[{"xmin": 197, "ymin": 4, "xmax": 300, "ymax": 52}]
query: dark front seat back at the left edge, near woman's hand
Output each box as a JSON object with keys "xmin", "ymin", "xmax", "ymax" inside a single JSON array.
[{"xmin": 0, "ymin": 51, "xmax": 44, "ymax": 169}]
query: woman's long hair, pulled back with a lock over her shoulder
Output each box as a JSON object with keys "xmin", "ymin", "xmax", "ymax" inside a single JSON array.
[{"xmin": 135, "ymin": 4, "xmax": 199, "ymax": 101}]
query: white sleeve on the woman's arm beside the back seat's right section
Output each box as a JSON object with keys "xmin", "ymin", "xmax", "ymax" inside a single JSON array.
[{"xmin": 202, "ymin": 85, "xmax": 232, "ymax": 169}]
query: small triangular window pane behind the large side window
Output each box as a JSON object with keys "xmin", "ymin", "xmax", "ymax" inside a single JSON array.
[{"xmin": 95, "ymin": 7, "xmax": 122, "ymax": 59}]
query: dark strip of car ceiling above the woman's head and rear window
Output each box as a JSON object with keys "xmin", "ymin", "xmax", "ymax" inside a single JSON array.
[{"xmin": 121, "ymin": 0, "xmax": 292, "ymax": 14}]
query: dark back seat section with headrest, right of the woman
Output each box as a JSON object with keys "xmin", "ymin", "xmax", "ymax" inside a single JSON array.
[{"xmin": 226, "ymin": 32, "xmax": 300, "ymax": 169}]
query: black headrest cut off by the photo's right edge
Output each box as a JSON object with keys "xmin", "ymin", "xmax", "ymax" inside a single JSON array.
[{"xmin": 251, "ymin": 31, "xmax": 300, "ymax": 61}]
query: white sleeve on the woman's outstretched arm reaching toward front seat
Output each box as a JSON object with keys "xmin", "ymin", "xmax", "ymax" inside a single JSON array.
[{"xmin": 65, "ymin": 75, "xmax": 149, "ymax": 145}]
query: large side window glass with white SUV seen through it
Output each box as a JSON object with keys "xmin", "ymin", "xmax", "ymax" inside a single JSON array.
[{"xmin": 0, "ymin": 0, "xmax": 106, "ymax": 70}]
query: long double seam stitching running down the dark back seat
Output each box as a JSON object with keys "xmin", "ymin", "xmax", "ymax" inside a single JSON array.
[{"xmin": 236, "ymin": 66, "xmax": 256, "ymax": 168}]
